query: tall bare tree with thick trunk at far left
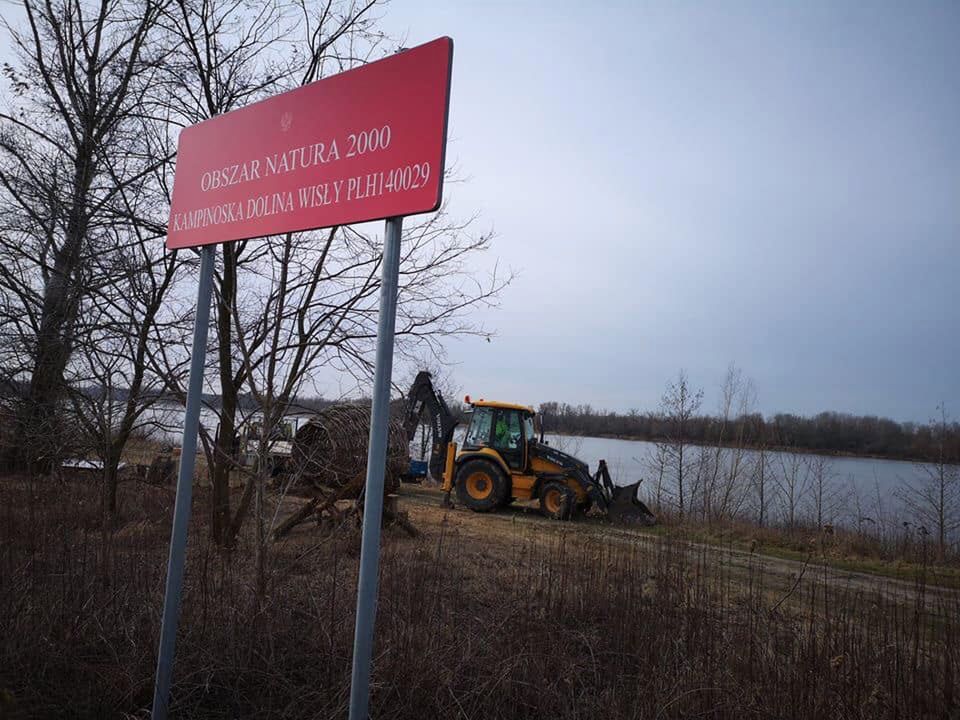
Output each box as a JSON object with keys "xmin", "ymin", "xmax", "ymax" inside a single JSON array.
[{"xmin": 0, "ymin": 0, "xmax": 162, "ymax": 467}]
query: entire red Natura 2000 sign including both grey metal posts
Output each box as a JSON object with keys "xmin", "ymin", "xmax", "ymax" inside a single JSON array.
[{"xmin": 153, "ymin": 37, "xmax": 453, "ymax": 720}]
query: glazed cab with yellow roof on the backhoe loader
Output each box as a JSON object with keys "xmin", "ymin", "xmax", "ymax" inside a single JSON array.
[{"xmin": 463, "ymin": 400, "xmax": 536, "ymax": 472}]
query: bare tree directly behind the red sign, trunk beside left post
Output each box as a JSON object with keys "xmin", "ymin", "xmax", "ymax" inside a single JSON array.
[{"xmin": 148, "ymin": 0, "xmax": 384, "ymax": 545}]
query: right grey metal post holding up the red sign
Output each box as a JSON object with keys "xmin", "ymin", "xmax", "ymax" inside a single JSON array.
[{"xmin": 350, "ymin": 217, "xmax": 403, "ymax": 720}]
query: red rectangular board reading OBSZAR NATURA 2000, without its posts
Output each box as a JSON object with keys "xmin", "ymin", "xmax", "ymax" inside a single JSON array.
[{"xmin": 167, "ymin": 38, "xmax": 453, "ymax": 249}]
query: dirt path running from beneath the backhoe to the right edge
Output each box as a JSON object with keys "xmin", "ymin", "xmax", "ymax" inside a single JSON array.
[{"xmin": 399, "ymin": 485, "xmax": 960, "ymax": 616}]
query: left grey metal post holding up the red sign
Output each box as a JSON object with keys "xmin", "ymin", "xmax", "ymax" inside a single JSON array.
[{"xmin": 151, "ymin": 245, "xmax": 216, "ymax": 720}]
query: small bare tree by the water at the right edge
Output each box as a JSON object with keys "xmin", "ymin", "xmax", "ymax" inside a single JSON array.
[{"xmin": 899, "ymin": 403, "xmax": 960, "ymax": 560}]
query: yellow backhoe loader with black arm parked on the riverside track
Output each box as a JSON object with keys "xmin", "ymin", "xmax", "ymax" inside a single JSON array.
[{"xmin": 404, "ymin": 372, "xmax": 656, "ymax": 525}]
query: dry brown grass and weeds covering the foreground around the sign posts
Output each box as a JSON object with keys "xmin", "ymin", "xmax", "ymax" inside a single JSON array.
[{"xmin": 0, "ymin": 479, "xmax": 960, "ymax": 719}]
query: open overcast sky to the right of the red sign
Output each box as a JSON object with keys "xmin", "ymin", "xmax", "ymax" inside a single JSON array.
[{"xmin": 374, "ymin": 0, "xmax": 960, "ymax": 420}]
